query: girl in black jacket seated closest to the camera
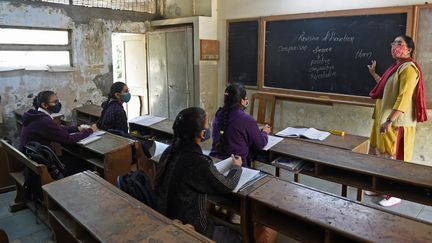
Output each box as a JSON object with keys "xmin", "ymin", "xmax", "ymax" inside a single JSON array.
[{"xmin": 155, "ymin": 107, "xmax": 242, "ymax": 242}]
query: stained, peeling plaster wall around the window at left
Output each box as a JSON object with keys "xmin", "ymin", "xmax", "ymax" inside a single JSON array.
[{"xmin": 0, "ymin": 1, "xmax": 154, "ymax": 138}]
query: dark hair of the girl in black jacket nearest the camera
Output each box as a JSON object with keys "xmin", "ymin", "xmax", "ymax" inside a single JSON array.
[{"xmin": 172, "ymin": 107, "xmax": 206, "ymax": 142}]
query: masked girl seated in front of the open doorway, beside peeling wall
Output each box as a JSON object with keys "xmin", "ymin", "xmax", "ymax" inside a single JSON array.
[{"xmin": 97, "ymin": 82, "xmax": 154, "ymax": 158}]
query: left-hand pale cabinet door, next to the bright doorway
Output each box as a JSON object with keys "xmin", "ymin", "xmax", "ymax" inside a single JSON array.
[{"xmin": 147, "ymin": 32, "xmax": 169, "ymax": 117}]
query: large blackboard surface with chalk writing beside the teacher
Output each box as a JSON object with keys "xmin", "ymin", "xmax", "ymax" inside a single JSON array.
[{"xmin": 264, "ymin": 13, "xmax": 407, "ymax": 96}]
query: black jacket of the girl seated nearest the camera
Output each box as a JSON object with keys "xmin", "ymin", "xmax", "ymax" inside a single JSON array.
[{"xmin": 155, "ymin": 141, "xmax": 241, "ymax": 236}]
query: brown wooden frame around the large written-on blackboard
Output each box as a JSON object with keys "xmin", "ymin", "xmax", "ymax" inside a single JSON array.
[{"xmin": 258, "ymin": 6, "xmax": 416, "ymax": 106}]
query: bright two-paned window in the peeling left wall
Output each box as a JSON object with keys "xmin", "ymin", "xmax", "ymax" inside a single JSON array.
[{"xmin": 0, "ymin": 27, "xmax": 71, "ymax": 70}]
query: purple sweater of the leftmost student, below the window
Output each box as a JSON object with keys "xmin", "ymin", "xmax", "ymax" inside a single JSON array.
[{"xmin": 20, "ymin": 110, "xmax": 93, "ymax": 151}]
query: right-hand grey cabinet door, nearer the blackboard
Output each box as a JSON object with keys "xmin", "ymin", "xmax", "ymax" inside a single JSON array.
[{"xmin": 166, "ymin": 28, "xmax": 194, "ymax": 119}]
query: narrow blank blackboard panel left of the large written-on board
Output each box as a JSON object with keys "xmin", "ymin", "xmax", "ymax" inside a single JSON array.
[{"xmin": 227, "ymin": 20, "xmax": 259, "ymax": 86}]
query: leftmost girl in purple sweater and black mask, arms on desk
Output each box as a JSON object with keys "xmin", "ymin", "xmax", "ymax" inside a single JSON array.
[{"xmin": 19, "ymin": 91, "xmax": 96, "ymax": 173}]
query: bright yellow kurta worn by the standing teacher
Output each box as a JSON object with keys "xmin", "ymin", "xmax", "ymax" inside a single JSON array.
[{"xmin": 370, "ymin": 62, "xmax": 419, "ymax": 161}]
